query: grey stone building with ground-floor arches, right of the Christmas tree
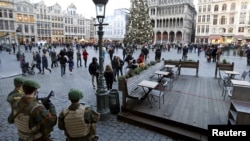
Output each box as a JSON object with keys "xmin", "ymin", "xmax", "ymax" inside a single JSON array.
[{"xmin": 148, "ymin": 0, "xmax": 196, "ymax": 43}]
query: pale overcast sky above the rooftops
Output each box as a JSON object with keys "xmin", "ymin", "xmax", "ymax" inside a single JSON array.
[{"xmin": 30, "ymin": 0, "xmax": 198, "ymax": 18}]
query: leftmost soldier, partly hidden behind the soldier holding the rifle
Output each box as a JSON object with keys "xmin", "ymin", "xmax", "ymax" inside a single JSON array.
[{"xmin": 7, "ymin": 77, "xmax": 25, "ymax": 124}]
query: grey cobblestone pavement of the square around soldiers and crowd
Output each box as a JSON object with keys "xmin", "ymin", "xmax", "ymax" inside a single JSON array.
[{"xmin": 0, "ymin": 48, "xmax": 249, "ymax": 141}]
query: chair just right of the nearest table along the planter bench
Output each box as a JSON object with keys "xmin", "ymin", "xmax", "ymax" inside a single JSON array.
[{"xmin": 149, "ymin": 81, "xmax": 168, "ymax": 109}]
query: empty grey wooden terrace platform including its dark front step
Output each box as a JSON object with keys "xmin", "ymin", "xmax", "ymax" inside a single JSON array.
[{"xmin": 117, "ymin": 75, "xmax": 230, "ymax": 140}]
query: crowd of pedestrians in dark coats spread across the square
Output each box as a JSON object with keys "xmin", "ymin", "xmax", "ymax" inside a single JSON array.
[{"xmin": 12, "ymin": 40, "xmax": 250, "ymax": 92}]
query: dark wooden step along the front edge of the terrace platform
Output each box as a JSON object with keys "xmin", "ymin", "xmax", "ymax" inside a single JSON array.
[{"xmin": 117, "ymin": 112, "xmax": 208, "ymax": 141}]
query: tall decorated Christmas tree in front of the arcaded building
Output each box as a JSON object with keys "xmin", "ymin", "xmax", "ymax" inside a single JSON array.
[{"xmin": 124, "ymin": 0, "xmax": 153, "ymax": 45}]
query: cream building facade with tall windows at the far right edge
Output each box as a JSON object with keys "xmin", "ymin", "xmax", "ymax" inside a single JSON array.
[{"xmin": 195, "ymin": 0, "xmax": 250, "ymax": 44}]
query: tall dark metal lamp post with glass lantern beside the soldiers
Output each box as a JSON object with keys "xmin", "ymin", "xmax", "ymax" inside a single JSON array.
[{"xmin": 93, "ymin": 0, "xmax": 110, "ymax": 120}]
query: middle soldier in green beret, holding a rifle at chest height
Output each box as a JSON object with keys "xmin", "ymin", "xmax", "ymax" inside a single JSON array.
[{"xmin": 13, "ymin": 80, "xmax": 57, "ymax": 141}]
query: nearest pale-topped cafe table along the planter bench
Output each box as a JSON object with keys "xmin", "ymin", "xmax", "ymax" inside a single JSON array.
[{"xmin": 138, "ymin": 80, "xmax": 159, "ymax": 107}]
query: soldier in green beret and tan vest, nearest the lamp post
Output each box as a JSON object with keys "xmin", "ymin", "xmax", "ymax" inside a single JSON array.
[{"xmin": 58, "ymin": 89, "xmax": 100, "ymax": 141}]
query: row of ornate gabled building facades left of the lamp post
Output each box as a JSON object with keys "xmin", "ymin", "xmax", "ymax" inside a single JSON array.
[{"xmin": 0, "ymin": 0, "xmax": 96, "ymax": 44}]
